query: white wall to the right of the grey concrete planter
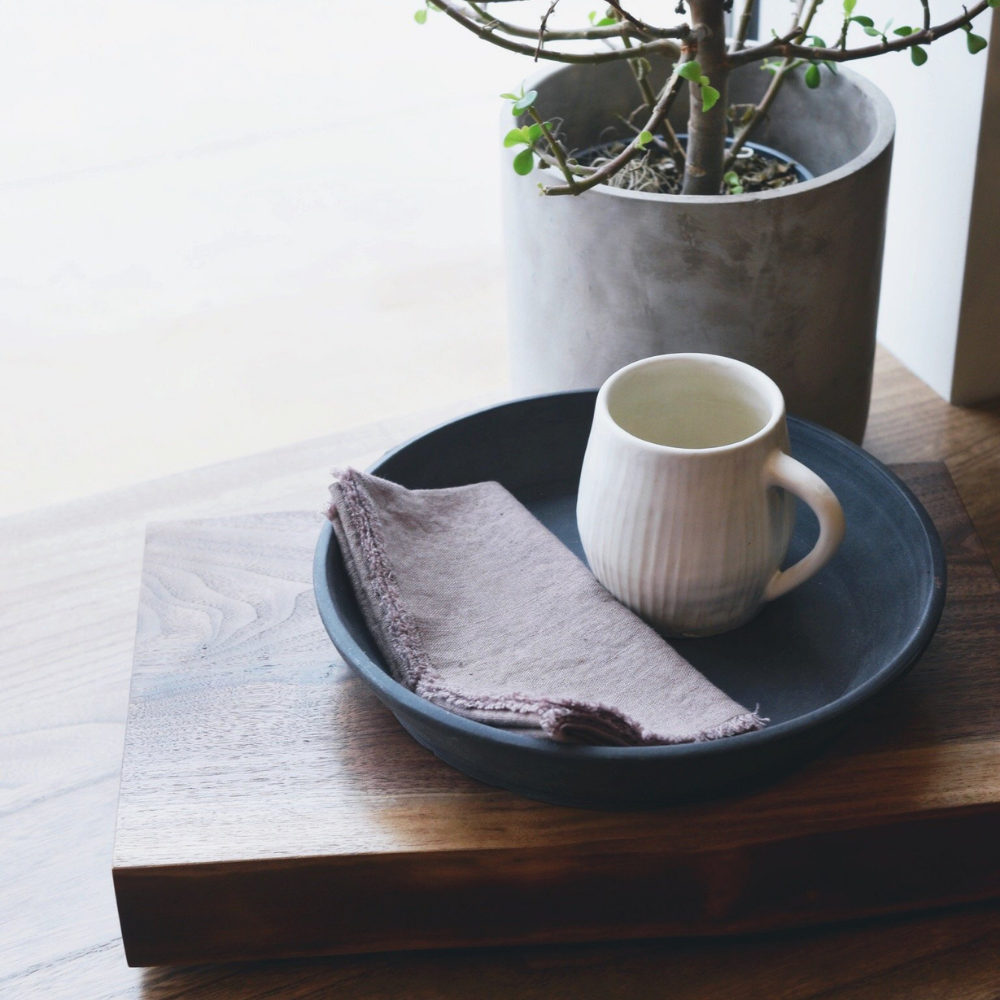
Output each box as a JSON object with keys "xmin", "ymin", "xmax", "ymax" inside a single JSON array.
[{"xmin": 761, "ymin": 0, "xmax": 1000, "ymax": 402}]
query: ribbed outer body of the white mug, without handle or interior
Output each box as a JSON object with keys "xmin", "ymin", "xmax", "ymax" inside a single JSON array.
[{"xmin": 577, "ymin": 360, "xmax": 795, "ymax": 635}]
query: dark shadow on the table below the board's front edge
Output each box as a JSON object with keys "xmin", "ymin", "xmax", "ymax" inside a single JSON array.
[{"xmin": 142, "ymin": 906, "xmax": 1000, "ymax": 1000}]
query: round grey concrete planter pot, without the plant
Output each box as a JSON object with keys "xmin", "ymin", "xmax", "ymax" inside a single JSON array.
[{"xmin": 503, "ymin": 64, "xmax": 895, "ymax": 441}]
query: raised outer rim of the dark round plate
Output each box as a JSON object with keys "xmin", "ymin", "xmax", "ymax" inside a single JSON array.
[{"xmin": 313, "ymin": 389, "xmax": 947, "ymax": 760}]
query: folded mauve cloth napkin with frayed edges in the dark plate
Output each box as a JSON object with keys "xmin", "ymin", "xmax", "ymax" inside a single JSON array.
[{"xmin": 328, "ymin": 469, "xmax": 766, "ymax": 746}]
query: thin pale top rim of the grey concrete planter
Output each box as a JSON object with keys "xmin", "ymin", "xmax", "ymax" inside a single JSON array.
[{"xmin": 524, "ymin": 64, "xmax": 896, "ymax": 205}]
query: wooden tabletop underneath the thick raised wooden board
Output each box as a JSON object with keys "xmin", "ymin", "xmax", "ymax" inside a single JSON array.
[{"xmin": 0, "ymin": 353, "xmax": 1000, "ymax": 1000}]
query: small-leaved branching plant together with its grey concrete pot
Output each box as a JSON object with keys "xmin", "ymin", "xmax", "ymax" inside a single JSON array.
[{"xmin": 417, "ymin": 0, "xmax": 1000, "ymax": 441}]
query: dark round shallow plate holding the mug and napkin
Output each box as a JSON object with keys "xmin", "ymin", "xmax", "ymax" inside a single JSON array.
[{"xmin": 314, "ymin": 392, "xmax": 945, "ymax": 808}]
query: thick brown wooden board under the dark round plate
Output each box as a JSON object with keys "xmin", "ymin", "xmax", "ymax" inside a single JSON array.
[{"xmin": 114, "ymin": 463, "xmax": 1000, "ymax": 965}]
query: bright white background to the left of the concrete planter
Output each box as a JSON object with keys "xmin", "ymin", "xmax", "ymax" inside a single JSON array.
[{"xmin": 0, "ymin": 0, "xmax": 516, "ymax": 516}]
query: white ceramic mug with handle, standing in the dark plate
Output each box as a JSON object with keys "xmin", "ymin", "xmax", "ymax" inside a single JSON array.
[{"xmin": 577, "ymin": 354, "xmax": 844, "ymax": 636}]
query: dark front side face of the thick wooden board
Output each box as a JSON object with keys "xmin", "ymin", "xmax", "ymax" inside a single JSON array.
[{"xmin": 113, "ymin": 805, "xmax": 1000, "ymax": 966}]
